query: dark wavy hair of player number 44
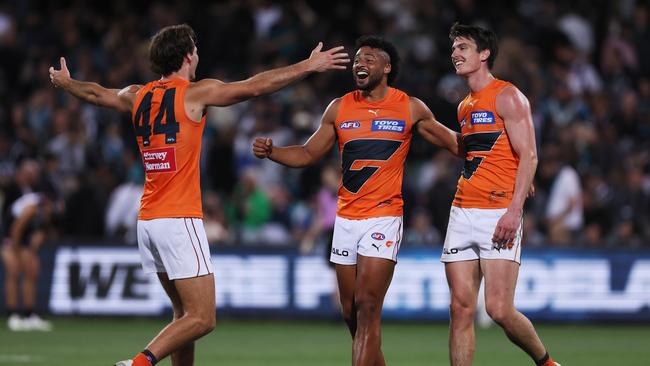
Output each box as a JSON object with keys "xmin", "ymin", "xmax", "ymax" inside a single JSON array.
[{"xmin": 149, "ymin": 24, "xmax": 196, "ymax": 76}]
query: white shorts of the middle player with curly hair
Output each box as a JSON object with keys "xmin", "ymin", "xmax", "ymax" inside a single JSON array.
[{"xmin": 330, "ymin": 216, "xmax": 403, "ymax": 265}]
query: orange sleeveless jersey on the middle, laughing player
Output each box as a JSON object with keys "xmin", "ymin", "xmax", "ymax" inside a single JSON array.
[{"xmin": 335, "ymin": 88, "xmax": 412, "ymax": 219}]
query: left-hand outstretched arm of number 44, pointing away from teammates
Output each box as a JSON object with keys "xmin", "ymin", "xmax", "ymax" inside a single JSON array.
[{"xmin": 50, "ymin": 57, "xmax": 140, "ymax": 113}]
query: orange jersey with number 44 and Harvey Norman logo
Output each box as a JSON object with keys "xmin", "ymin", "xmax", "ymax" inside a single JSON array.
[{"xmin": 132, "ymin": 78, "xmax": 205, "ymax": 220}]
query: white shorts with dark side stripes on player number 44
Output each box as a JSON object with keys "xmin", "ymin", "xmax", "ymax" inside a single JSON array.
[{"xmin": 138, "ymin": 218, "xmax": 213, "ymax": 280}]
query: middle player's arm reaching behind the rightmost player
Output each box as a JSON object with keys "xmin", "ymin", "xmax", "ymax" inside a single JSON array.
[{"xmin": 410, "ymin": 97, "xmax": 465, "ymax": 158}]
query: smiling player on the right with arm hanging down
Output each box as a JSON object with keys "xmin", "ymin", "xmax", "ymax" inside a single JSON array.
[{"xmin": 442, "ymin": 24, "xmax": 557, "ymax": 366}]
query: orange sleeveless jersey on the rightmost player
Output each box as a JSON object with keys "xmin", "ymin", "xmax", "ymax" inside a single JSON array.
[{"xmin": 453, "ymin": 79, "xmax": 519, "ymax": 208}]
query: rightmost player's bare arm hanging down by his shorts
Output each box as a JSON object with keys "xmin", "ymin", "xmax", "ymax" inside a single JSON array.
[{"xmin": 492, "ymin": 87, "xmax": 537, "ymax": 244}]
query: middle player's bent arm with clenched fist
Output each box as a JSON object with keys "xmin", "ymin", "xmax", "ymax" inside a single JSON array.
[{"xmin": 253, "ymin": 99, "xmax": 340, "ymax": 168}]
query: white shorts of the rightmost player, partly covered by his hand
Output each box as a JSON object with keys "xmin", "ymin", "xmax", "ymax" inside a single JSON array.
[{"xmin": 440, "ymin": 206, "xmax": 523, "ymax": 263}]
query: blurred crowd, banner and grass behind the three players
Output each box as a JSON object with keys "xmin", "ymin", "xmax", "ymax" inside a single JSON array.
[{"xmin": 0, "ymin": 0, "xmax": 650, "ymax": 366}]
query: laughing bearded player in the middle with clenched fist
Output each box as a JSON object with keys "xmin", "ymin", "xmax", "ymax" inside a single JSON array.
[{"xmin": 253, "ymin": 36, "xmax": 459, "ymax": 366}]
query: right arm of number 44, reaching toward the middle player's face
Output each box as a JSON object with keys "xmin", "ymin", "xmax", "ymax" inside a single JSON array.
[{"xmin": 186, "ymin": 43, "xmax": 350, "ymax": 106}]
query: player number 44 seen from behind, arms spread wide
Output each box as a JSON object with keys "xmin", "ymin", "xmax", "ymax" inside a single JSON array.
[{"xmin": 50, "ymin": 25, "xmax": 349, "ymax": 366}]
